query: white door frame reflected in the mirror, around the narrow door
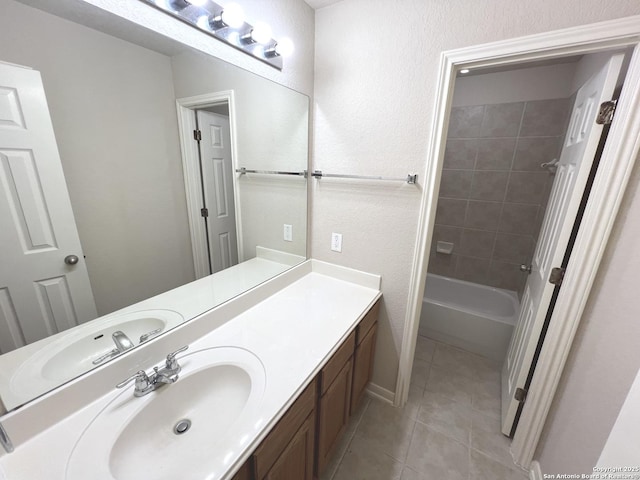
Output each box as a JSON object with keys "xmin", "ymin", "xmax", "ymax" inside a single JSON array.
[{"xmin": 176, "ymin": 90, "xmax": 244, "ymax": 279}]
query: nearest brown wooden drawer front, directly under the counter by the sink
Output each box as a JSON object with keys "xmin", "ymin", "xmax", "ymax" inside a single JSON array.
[{"xmin": 253, "ymin": 379, "xmax": 317, "ymax": 479}]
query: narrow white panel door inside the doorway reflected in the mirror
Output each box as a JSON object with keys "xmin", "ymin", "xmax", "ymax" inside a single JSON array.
[{"xmin": 196, "ymin": 110, "xmax": 238, "ymax": 273}]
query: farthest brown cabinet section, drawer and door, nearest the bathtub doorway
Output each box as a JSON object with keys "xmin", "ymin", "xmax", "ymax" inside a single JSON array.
[{"xmin": 350, "ymin": 301, "xmax": 380, "ymax": 413}]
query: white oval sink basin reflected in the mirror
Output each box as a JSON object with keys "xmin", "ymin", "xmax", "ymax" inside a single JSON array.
[{"xmin": 11, "ymin": 309, "xmax": 184, "ymax": 395}]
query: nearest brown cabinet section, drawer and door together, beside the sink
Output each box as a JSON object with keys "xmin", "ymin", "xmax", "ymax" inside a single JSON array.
[{"xmin": 253, "ymin": 380, "xmax": 317, "ymax": 480}]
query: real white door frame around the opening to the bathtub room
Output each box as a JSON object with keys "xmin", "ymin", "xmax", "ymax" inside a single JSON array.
[{"xmin": 395, "ymin": 16, "xmax": 640, "ymax": 469}]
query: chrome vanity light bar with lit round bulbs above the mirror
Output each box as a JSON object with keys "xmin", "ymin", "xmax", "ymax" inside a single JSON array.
[{"xmin": 140, "ymin": 0, "xmax": 293, "ymax": 70}]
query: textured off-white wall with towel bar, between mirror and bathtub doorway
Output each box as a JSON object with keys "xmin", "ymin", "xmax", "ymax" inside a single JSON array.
[{"xmin": 312, "ymin": 0, "xmax": 640, "ymax": 406}]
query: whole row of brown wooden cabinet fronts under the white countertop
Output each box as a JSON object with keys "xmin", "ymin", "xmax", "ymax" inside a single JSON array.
[{"xmin": 239, "ymin": 301, "xmax": 380, "ymax": 480}]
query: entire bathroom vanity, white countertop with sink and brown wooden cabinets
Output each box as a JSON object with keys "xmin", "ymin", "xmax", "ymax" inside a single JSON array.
[{"xmin": 0, "ymin": 260, "xmax": 381, "ymax": 480}]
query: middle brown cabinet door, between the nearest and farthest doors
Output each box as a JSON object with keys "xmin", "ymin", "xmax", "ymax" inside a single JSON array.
[{"xmin": 317, "ymin": 358, "xmax": 353, "ymax": 475}]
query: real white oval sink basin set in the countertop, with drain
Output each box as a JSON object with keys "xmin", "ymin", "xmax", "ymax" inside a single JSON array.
[{"xmin": 66, "ymin": 347, "xmax": 265, "ymax": 480}]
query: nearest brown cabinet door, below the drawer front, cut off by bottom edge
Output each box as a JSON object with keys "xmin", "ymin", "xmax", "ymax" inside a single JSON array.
[{"xmin": 265, "ymin": 414, "xmax": 315, "ymax": 480}]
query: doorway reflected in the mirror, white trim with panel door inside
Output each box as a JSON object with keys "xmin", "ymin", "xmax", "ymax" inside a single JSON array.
[{"xmin": 176, "ymin": 90, "xmax": 242, "ymax": 278}]
